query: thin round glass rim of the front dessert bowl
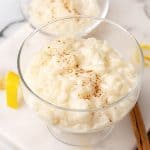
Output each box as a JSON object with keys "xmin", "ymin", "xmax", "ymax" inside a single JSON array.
[{"xmin": 17, "ymin": 16, "xmax": 144, "ymax": 112}]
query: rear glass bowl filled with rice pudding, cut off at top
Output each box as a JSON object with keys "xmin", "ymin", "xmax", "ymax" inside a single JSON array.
[{"xmin": 20, "ymin": 0, "xmax": 109, "ymax": 34}]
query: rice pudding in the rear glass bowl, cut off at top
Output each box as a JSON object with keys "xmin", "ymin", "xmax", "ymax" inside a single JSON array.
[{"xmin": 28, "ymin": 0, "xmax": 100, "ymax": 33}]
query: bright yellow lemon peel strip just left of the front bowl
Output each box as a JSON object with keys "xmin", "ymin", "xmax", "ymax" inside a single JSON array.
[{"xmin": 5, "ymin": 72, "xmax": 19, "ymax": 109}]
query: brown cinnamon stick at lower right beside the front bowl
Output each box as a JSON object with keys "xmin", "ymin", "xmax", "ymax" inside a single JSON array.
[{"xmin": 130, "ymin": 103, "xmax": 150, "ymax": 150}]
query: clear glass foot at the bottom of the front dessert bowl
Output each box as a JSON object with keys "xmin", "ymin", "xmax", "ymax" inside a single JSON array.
[{"xmin": 48, "ymin": 126, "xmax": 113, "ymax": 146}]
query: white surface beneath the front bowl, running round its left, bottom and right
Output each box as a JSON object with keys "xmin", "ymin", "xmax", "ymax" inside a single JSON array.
[{"xmin": 0, "ymin": 24, "xmax": 150, "ymax": 150}]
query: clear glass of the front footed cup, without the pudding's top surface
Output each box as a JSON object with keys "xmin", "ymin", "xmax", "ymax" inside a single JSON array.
[{"xmin": 17, "ymin": 17, "xmax": 143, "ymax": 146}]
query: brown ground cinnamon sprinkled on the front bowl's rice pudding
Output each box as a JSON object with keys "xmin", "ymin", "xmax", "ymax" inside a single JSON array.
[{"xmin": 49, "ymin": 40, "xmax": 102, "ymax": 100}]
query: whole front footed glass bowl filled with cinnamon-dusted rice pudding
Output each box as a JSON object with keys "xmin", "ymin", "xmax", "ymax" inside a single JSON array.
[{"xmin": 18, "ymin": 17, "xmax": 143, "ymax": 146}]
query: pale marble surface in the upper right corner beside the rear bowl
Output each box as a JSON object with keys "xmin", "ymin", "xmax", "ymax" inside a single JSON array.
[{"xmin": 108, "ymin": 0, "xmax": 150, "ymax": 42}]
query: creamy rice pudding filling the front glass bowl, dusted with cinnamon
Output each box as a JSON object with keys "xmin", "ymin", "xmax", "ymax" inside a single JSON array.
[{"xmin": 24, "ymin": 37, "xmax": 137, "ymax": 132}]
